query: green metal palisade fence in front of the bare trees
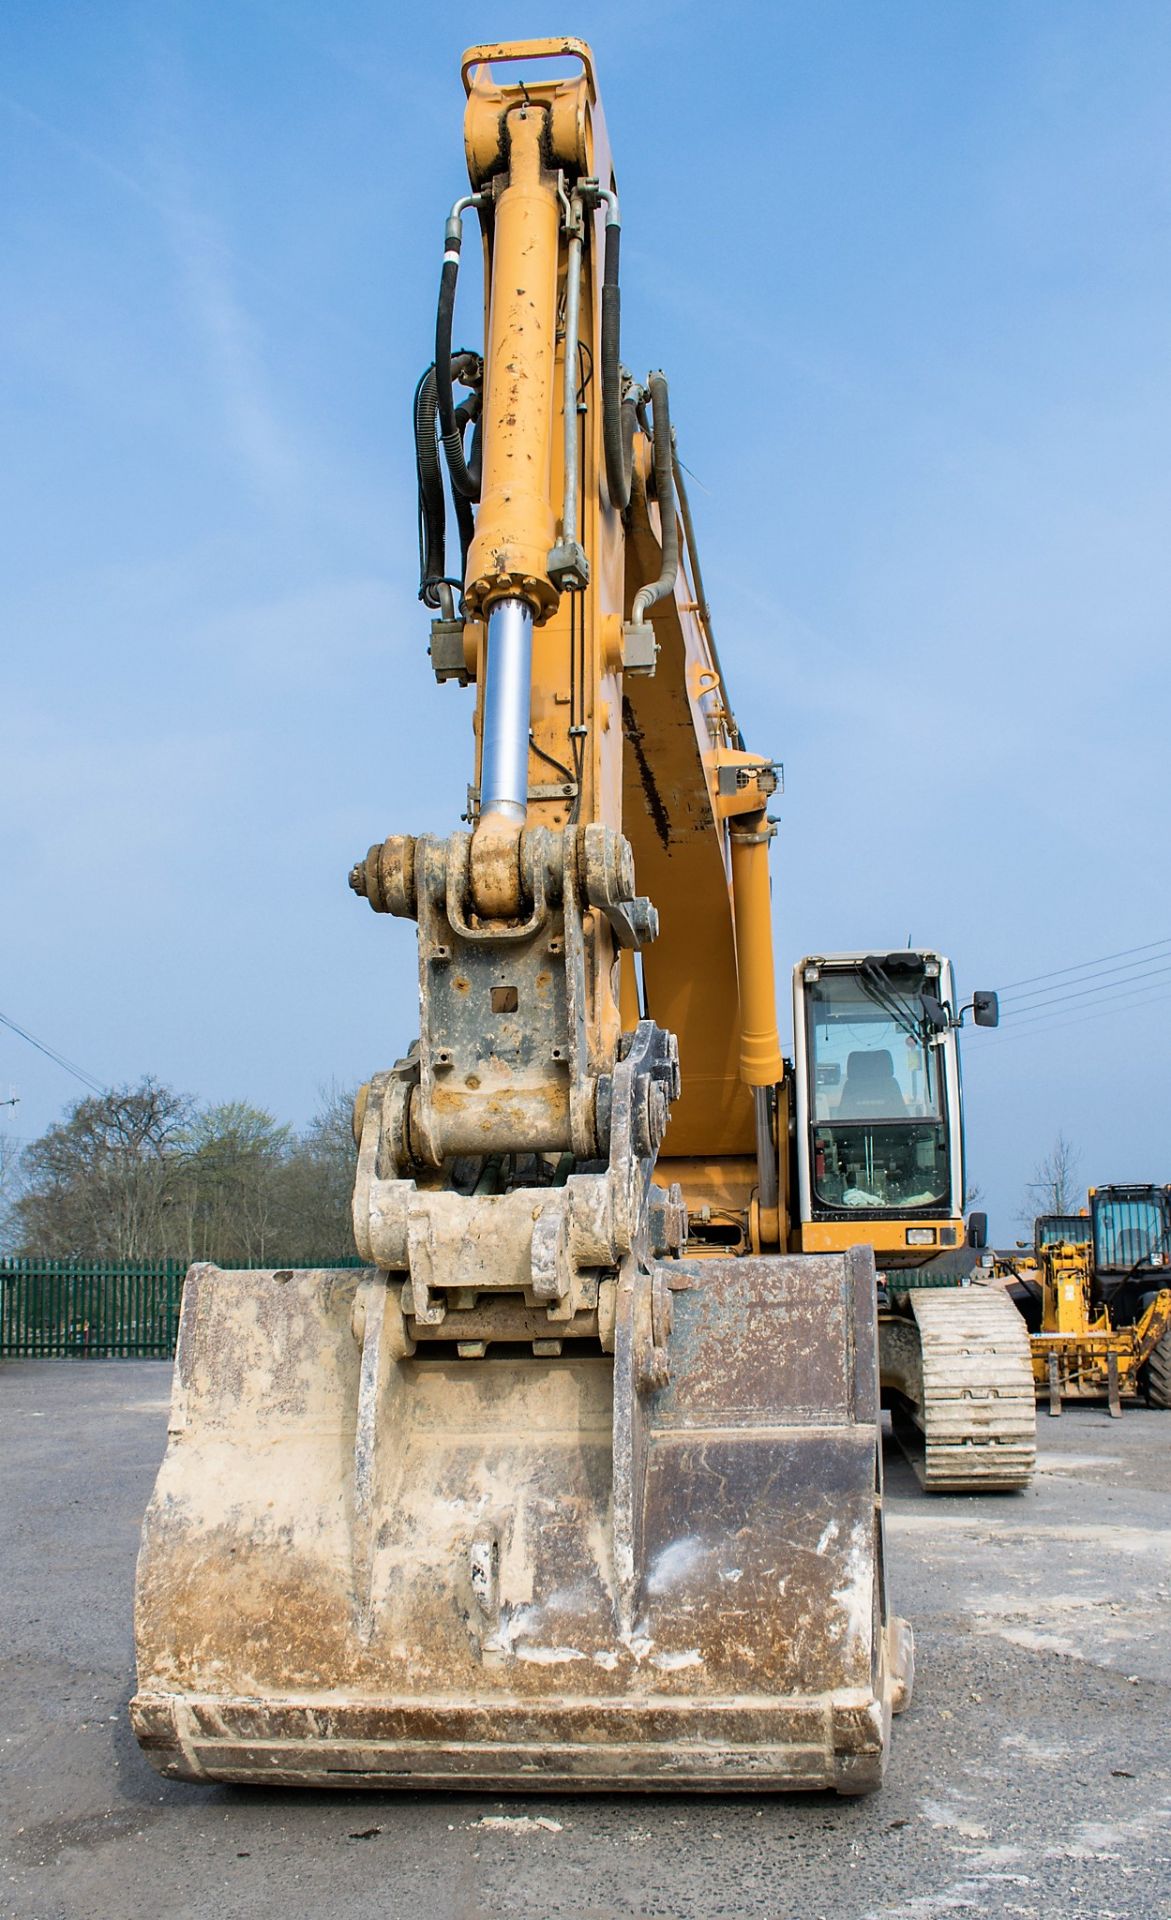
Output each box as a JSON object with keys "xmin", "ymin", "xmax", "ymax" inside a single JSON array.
[{"xmin": 0, "ymin": 1256, "xmax": 361, "ymax": 1359}]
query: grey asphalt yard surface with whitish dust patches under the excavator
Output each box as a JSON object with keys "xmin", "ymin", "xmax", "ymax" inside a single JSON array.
[{"xmin": 0, "ymin": 1361, "xmax": 1171, "ymax": 1920}]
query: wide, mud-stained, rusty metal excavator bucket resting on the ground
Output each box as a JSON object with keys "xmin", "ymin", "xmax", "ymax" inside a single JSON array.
[{"xmin": 132, "ymin": 1250, "xmax": 910, "ymax": 1793}]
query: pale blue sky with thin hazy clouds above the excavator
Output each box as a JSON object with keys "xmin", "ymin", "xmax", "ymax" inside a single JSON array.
[{"xmin": 0, "ymin": 0, "xmax": 1171, "ymax": 1238}]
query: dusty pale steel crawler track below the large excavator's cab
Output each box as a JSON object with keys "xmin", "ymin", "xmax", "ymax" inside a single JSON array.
[{"xmin": 895, "ymin": 1286, "xmax": 1037, "ymax": 1494}]
